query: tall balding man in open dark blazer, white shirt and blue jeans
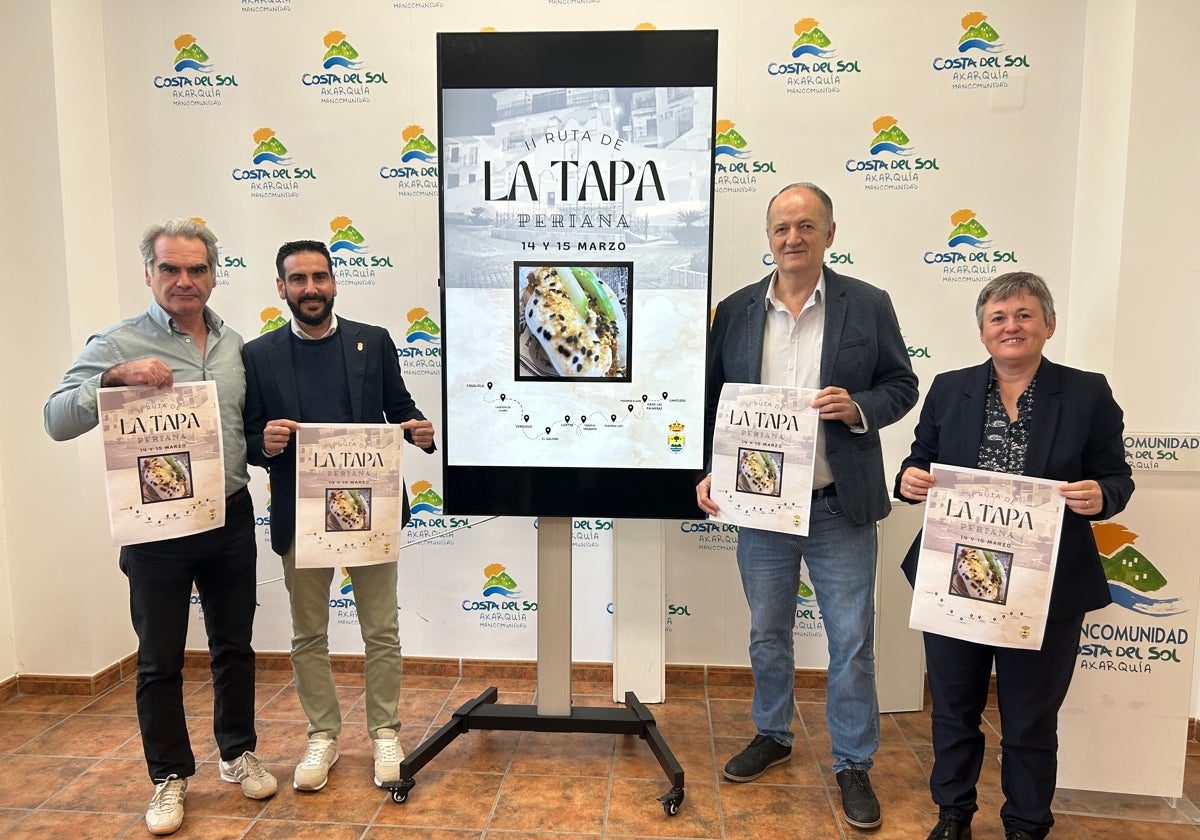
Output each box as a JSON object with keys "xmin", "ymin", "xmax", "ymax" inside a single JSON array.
[{"xmin": 696, "ymin": 184, "xmax": 917, "ymax": 828}]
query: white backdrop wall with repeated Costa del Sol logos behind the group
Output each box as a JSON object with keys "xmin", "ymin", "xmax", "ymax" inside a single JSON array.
[{"xmin": 112, "ymin": 0, "xmax": 1089, "ymax": 672}]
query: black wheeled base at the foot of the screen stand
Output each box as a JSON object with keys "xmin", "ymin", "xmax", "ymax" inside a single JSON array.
[{"xmin": 384, "ymin": 686, "xmax": 684, "ymax": 816}]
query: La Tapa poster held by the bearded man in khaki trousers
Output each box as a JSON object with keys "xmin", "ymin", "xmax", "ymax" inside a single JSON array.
[{"xmin": 296, "ymin": 424, "xmax": 404, "ymax": 569}]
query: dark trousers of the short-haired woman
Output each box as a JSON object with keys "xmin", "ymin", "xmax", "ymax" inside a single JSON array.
[{"xmin": 924, "ymin": 616, "xmax": 1084, "ymax": 838}]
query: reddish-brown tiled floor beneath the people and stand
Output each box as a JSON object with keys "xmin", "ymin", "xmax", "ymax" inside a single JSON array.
[{"xmin": 0, "ymin": 670, "xmax": 1200, "ymax": 840}]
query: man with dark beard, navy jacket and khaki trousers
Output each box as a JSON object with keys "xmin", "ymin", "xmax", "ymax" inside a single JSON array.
[{"xmin": 242, "ymin": 240, "xmax": 434, "ymax": 791}]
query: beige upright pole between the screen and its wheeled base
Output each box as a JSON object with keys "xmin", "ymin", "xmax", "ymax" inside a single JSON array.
[{"xmin": 538, "ymin": 516, "xmax": 571, "ymax": 715}]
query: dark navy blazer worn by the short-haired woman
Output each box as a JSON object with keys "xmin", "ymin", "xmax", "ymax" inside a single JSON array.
[{"xmin": 894, "ymin": 359, "xmax": 1133, "ymax": 619}]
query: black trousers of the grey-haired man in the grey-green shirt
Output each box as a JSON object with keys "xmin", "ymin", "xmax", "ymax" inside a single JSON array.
[{"xmin": 120, "ymin": 488, "xmax": 258, "ymax": 781}]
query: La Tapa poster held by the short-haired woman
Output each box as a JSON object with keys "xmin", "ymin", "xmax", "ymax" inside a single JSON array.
[{"xmin": 908, "ymin": 463, "xmax": 1066, "ymax": 650}]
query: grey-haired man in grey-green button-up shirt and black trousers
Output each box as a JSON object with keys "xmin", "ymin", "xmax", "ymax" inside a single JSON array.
[{"xmin": 43, "ymin": 218, "xmax": 277, "ymax": 834}]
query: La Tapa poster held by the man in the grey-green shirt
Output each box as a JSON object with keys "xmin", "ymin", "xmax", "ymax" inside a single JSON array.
[{"xmin": 96, "ymin": 382, "xmax": 224, "ymax": 546}]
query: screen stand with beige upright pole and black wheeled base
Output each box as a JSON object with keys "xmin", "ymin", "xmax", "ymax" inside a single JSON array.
[{"xmin": 385, "ymin": 516, "xmax": 684, "ymax": 816}]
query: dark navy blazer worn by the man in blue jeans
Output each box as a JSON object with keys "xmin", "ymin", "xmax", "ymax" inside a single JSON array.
[{"xmin": 704, "ymin": 266, "xmax": 917, "ymax": 524}]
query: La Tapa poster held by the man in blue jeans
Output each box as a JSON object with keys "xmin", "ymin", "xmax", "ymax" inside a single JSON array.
[{"xmin": 709, "ymin": 383, "xmax": 820, "ymax": 536}]
